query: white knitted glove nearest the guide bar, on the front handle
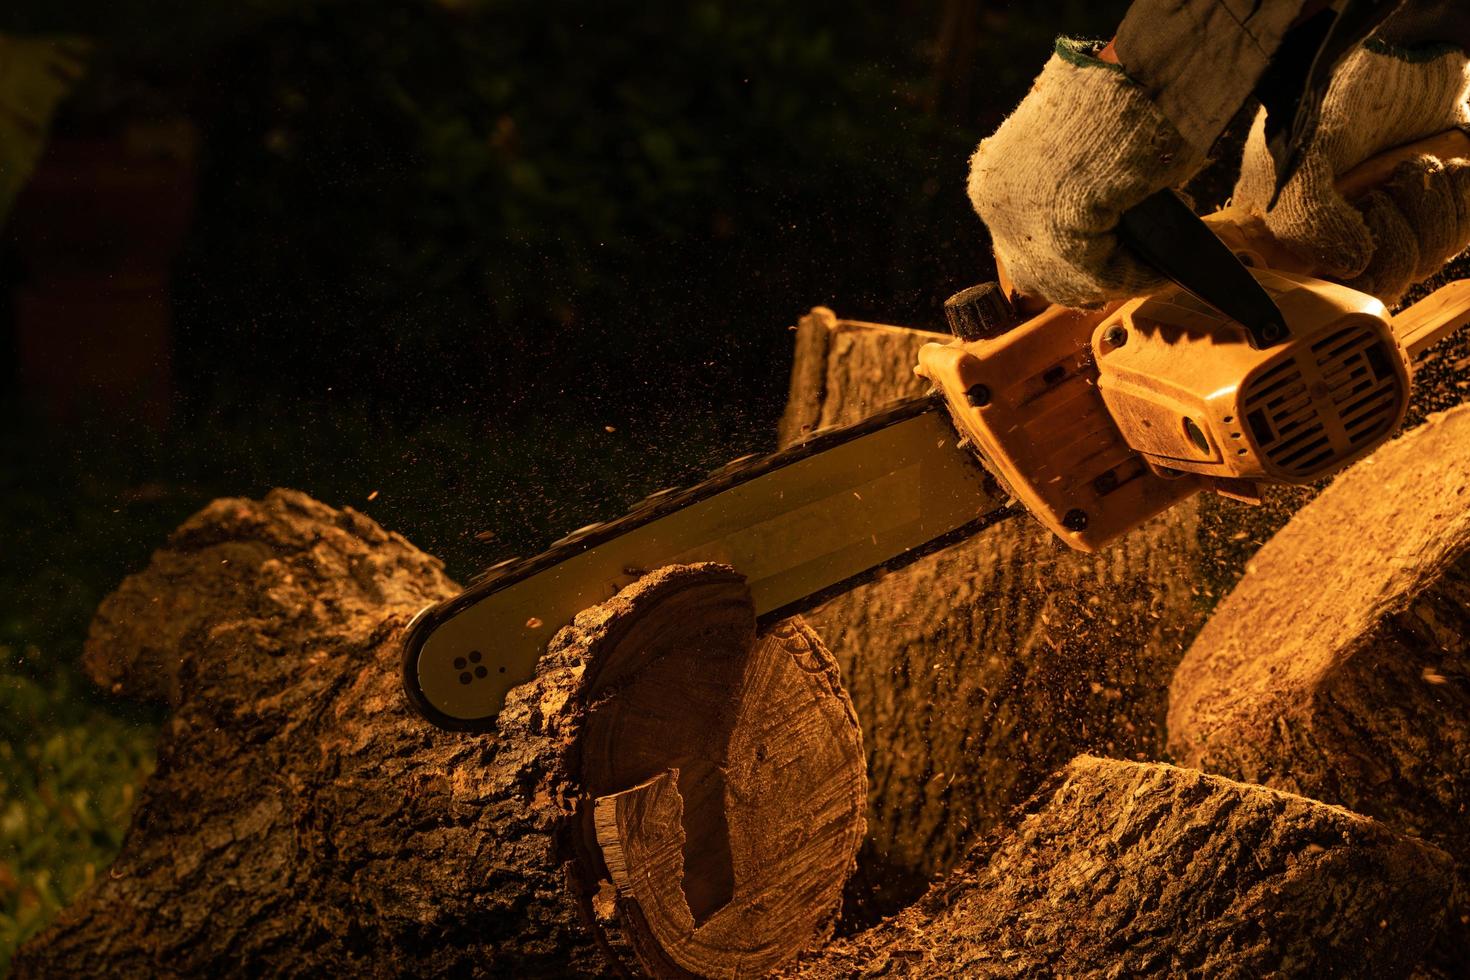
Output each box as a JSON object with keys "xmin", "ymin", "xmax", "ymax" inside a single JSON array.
[{"xmin": 969, "ymin": 38, "xmax": 1205, "ymax": 307}]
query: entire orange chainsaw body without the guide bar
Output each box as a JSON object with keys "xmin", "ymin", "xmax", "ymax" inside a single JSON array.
[{"xmin": 914, "ymin": 269, "xmax": 1470, "ymax": 551}]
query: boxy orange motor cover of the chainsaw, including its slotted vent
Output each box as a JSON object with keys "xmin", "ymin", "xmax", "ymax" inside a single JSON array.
[{"xmin": 1092, "ymin": 272, "xmax": 1410, "ymax": 483}]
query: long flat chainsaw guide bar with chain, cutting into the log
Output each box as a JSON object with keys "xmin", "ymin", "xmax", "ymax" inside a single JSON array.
[{"xmin": 403, "ymin": 395, "xmax": 1020, "ymax": 732}]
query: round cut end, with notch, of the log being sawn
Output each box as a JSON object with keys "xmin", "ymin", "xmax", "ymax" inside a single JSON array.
[{"xmin": 581, "ymin": 567, "xmax": 866, "ymax": 977}]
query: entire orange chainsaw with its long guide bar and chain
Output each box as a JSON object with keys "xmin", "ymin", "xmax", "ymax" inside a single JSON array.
[{"xmin": 403, "ymin": 131, "xmax": 1470, "ymax": 732}]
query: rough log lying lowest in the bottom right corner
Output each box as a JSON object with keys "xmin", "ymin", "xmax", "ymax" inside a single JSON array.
[{"xmin": 788, "ymin": 757, "xmax": 1449, "ymax": 980}]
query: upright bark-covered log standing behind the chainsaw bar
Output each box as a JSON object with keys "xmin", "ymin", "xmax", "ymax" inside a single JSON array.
[{"xmin": 781, "ymin": 309, "xmax": 1204, "ymax": 914}]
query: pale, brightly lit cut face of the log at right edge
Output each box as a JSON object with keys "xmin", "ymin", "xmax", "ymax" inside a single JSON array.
[{"xmin": 1169, "ymin": 408, "xmax": 1470, "ymax": 761}]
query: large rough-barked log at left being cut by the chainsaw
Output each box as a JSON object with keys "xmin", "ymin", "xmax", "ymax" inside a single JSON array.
[{"xmin": 15, "ymin": 491, "xmax": 866, "ymax": 977}]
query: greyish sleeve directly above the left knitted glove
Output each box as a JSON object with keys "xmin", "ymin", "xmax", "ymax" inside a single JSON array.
[{"xmin": 1113, "ymin": 0, "xmax": 1311, "ymax": 153}]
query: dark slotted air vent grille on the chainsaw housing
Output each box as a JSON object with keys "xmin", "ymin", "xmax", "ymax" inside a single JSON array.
[{"xmin": 1241, "ymin": 323, "xmax": 1408, "ymax": 478}]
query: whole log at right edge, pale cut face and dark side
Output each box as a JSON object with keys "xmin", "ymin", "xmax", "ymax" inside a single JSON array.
[{"xmin": 1169, "ymin": 407, "xmax": 1470, "ymax": 964}]
